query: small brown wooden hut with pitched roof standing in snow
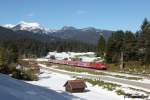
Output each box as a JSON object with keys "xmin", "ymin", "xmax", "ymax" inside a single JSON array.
[{"xmin": 64, "ymin": 80, "xmax": 87, "ymax": 92}]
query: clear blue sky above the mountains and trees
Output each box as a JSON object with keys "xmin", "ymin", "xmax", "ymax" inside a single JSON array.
[{"xmin": 0, "ymin": 0, "xmax": 150, "ymax": 32}]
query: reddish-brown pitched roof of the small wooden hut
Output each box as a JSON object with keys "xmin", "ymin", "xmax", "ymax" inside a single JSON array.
[{"xmin": 64, "ymin": 80, "xmax": 87, "ymax": 89}]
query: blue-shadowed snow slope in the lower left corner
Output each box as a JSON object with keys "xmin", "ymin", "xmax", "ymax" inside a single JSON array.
[{"xmin": 0, "ymin": 74, "xmax": 69, "ymax": 100}]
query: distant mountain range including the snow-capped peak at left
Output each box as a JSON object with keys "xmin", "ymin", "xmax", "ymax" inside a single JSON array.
[{"xmin": 4, "ymin": 21, "xmax": 112, "ymax": 44}]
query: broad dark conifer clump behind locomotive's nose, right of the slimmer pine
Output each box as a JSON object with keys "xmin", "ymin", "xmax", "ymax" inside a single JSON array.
[{"xmin": 106, "ymin": 31, "xmax": 124, "ymax": 63}]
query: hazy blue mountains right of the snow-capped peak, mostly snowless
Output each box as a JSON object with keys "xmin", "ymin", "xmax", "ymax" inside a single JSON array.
[{"xmin": 49, "ymin": 26, "xmax": 112, "ymax": 44}]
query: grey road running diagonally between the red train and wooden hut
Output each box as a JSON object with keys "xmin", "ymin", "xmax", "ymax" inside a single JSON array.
[{"xmin": 40, "ymin": 65, "xmax": 150, "ymax": 92}]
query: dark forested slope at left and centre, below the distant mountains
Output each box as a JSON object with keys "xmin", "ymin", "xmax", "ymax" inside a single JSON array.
[{"xmin": 0, "ymin": 27, "xmax": 95, "ymax": 53}]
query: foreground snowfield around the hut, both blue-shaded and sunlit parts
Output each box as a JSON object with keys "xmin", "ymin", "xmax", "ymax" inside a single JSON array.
[{"xmin": 0, "ymin": 70, "xmax": 149, "ymax": 100}]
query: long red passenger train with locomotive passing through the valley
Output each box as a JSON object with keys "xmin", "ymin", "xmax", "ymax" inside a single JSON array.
[{"xmin": 49, "ymin": 55, "xmax": 107, "ymax": 70}]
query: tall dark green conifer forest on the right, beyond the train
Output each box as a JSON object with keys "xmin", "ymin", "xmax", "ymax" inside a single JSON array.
[{"xmin": 97, "ymin": 18, "xmax": 150, "ymax": 71}]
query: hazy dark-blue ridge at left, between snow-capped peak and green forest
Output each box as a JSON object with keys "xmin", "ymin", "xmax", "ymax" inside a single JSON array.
[{"xmin": 0, "ymin": 26, "xmax": 61, "ymax": 42}]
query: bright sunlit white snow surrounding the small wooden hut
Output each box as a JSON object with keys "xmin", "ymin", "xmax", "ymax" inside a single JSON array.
[{"xmin": 28, "ymin": 70, "xmax": 129, "ymax": 100}]
